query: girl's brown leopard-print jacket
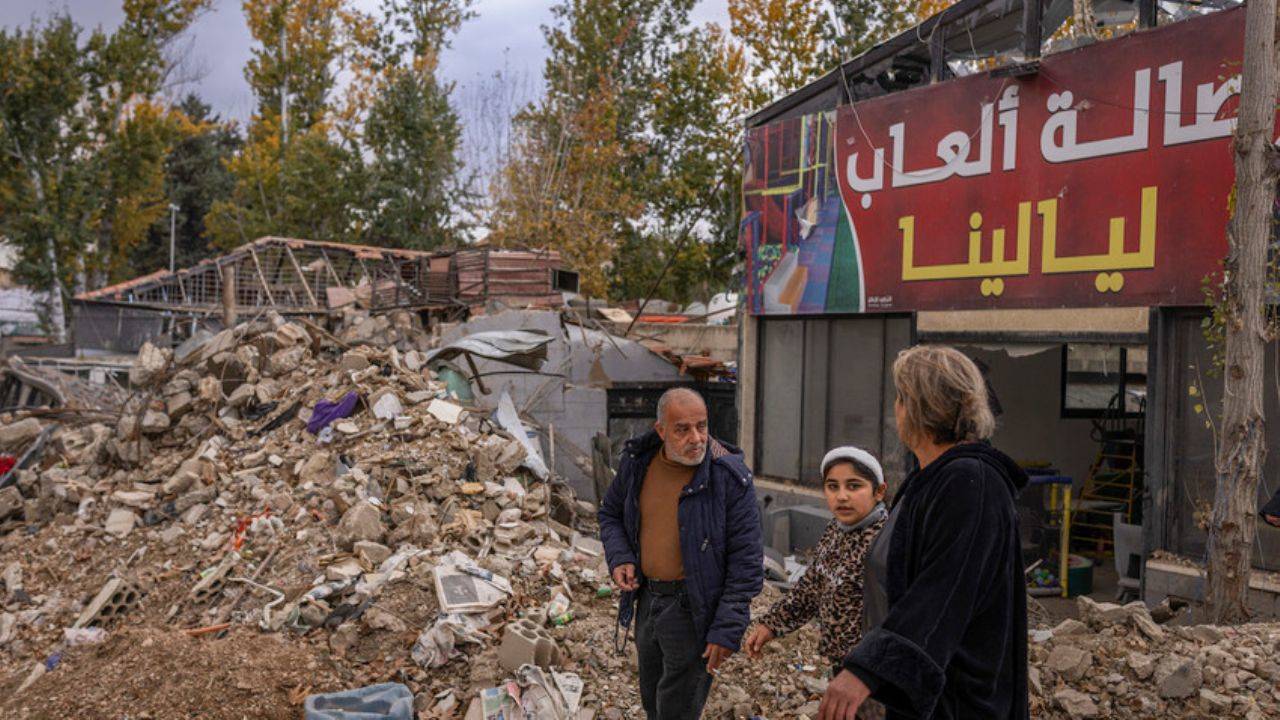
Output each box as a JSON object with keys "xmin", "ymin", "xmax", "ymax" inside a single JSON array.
[{"xmin": 760, "ymin": 519, "xmax": 884, "ymax": 664}]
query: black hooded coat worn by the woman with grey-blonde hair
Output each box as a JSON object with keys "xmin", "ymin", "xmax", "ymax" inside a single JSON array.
[{"xmin": 845, "ymin": 443, "xmax": 1029, "ymax": 720}]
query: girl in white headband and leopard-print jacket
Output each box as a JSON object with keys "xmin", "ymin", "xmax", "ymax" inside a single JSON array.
[{"xmin": 745, "ymin": 446, "xmax": 887, "ymax": 691}]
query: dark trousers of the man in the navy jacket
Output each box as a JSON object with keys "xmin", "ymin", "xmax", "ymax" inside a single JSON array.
[{"xmin": 636, "ymin": 580, "xmax": 712, "ymax": 720}]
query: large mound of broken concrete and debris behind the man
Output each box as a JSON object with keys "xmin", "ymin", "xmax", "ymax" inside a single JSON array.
[{"xmin": 0, "ymin": 314, "xmax": 839, "ymax": 720}]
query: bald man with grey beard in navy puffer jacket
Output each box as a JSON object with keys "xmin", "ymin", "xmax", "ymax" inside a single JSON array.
[{"xmin": 599, "ymin": 388, "xmax": 764, "ymax": 720}]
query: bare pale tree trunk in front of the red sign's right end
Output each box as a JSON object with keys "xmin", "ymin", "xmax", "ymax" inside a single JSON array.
[{"xmin": 1204, "ymin": 0, "xmax": 1280, "ymax": 624}]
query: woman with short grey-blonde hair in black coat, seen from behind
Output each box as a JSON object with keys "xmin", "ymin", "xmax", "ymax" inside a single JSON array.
[{"xmin": 819, "ymin": 346, "xmax": 1030, "ymax": 720}]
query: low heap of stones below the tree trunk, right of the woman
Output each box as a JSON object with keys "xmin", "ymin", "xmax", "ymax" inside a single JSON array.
[{"xmin": 1028, "ymin": 597, "xmax": 1280, "ymax": 720}]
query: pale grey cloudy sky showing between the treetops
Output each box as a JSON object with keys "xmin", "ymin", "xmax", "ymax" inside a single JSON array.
[{"xmin": 0, "ymin": 0, "xmax": 727, "ymax": 120}]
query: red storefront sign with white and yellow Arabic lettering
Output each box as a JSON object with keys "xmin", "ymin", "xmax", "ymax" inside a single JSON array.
[{"xmin": 741, "ymin": 9, "xmax": 1244, "ymax": 314}]
